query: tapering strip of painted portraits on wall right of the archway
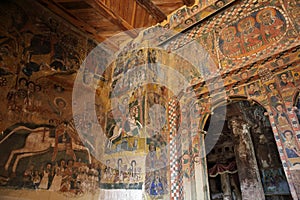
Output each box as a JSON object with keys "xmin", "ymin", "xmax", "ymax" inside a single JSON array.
[{"xmin": 260, "ymin": 66, "xmax": 300, "ymax": 199}]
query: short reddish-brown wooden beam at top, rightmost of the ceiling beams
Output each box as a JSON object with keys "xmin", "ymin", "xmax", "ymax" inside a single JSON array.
[{"xmin": 136, "ymin": 0, "xmax": 167, "ymax": 22}]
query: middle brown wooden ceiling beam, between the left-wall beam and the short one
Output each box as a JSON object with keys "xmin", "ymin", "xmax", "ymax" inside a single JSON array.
[{"xmin": 85, "ymin": 0, "xmax": 138, "ymax": 37}]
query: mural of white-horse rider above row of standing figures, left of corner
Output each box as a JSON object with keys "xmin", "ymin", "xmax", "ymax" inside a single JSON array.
[{"xmin": 100, "ymin": 85, "xmax": 146, "ymax": 189}]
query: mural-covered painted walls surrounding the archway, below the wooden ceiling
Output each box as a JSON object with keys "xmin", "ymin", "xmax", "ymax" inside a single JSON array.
[{"xmin": 0, "ymin": 0, "xmax": 300, "ymax": 199}]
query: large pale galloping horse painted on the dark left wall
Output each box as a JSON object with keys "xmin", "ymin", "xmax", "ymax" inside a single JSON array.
[{"xmin": 0, "ymin": 123, "xmax": 91, "ymax": 173}]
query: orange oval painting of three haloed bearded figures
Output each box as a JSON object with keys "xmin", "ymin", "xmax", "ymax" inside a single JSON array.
[{"xmin": 219, "ymin": 7, "xmax": 286, "ymax": 57}]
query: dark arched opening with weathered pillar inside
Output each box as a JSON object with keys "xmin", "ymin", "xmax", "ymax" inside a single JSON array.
[{"xmin": 204, "ymin": 99, "xmax": 292, "ymax": 200}]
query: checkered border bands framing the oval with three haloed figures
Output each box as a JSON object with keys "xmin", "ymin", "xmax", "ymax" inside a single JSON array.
[{"xmin": 164, "ymin": 0, "xmax": 300, "ymax": 77}]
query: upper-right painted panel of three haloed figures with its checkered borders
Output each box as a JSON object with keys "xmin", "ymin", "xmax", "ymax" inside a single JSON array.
[{"xmin": 159, "ymin": 1, "xmax": 297, "ymax": 75}]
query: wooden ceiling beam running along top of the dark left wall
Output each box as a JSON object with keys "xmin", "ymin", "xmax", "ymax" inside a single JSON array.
[{"xmin": 38, "ymin": 0, "xmax": 119, "ymax": 50}]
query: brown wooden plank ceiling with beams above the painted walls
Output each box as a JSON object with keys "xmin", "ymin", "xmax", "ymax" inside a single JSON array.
[{"xmin": 38, "ymin": 0, "xmax": 195, "ymax": 47}]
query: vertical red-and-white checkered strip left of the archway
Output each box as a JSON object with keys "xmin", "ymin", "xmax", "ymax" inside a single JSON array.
[{"xmin": 168, "ymin": 98, "xmax": 183, "ymax": 200}]
